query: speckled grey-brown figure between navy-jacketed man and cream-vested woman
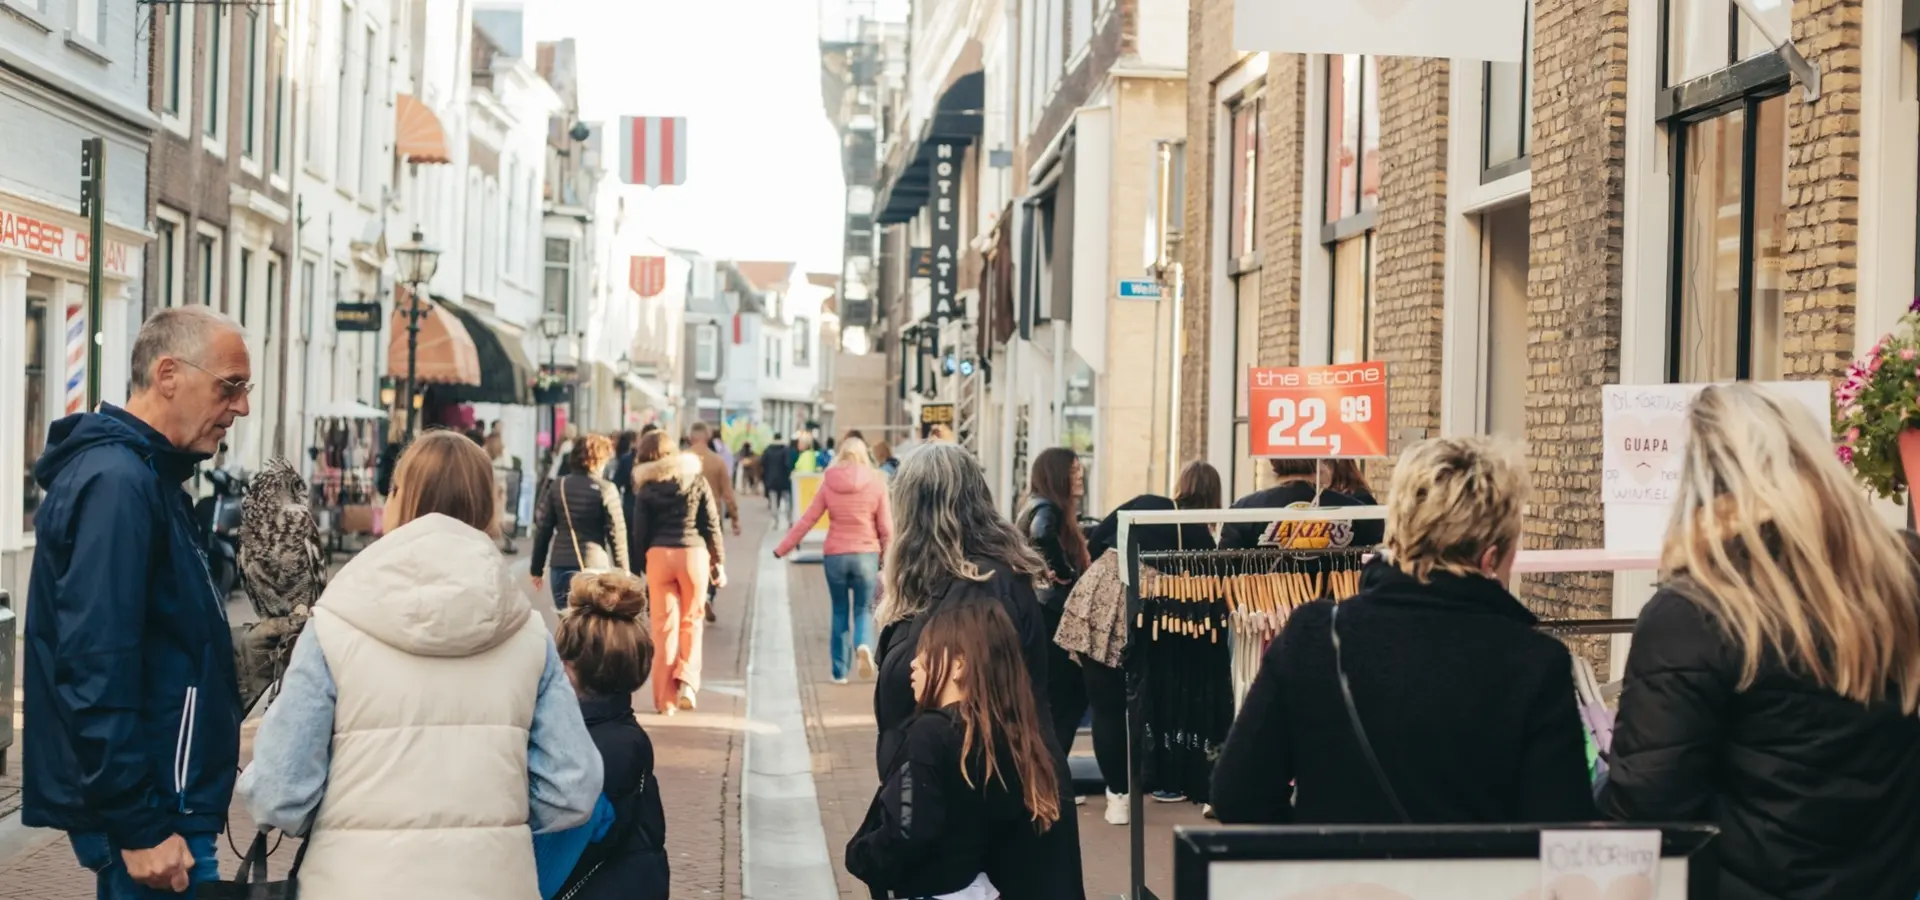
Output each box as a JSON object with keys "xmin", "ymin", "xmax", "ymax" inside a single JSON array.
[{"xmin": 234, "ymin": 459, "xmax": 326, "ymax": 708}]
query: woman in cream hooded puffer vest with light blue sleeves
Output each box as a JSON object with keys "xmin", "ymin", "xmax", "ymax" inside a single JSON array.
[{"xmin": 240, "ymin": 430, "xmax": 603, "ymax": 900}]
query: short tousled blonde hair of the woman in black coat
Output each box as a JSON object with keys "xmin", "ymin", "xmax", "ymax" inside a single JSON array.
[{"xmin": 1386, "ymin": 438, "xmax": 1528, "ymax": 583}]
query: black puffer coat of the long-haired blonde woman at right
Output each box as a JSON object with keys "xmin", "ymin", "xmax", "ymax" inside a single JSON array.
[{"xmin": 1601, "ymin": 589, "xmax": 1920, "ymax": 900}]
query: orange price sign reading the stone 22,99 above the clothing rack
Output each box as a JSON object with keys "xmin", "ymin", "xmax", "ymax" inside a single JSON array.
[{"xmin": 1246, "ymin": 361, "xmax": 1386, "ymax": 459}]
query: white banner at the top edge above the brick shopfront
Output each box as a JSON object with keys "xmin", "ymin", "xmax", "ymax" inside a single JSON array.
[{"xmin": 1233, "ymin": 0, "xmax": 1526, "ymax": 63}]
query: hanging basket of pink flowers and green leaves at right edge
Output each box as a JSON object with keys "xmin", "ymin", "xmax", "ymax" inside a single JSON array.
[{"xmin": 1834, "ymin": 299, "xmax": 1920, "ymax": 501}]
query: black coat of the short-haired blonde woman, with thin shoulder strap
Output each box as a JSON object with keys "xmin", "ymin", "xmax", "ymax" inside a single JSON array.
[{"xmin": 1213, "ymin": 560, "xmax": 1596, "ymax": 825}]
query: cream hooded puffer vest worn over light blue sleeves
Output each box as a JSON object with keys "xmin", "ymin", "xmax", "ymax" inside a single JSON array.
[{"xmin": 300, "ymin": 514, "xmax": 547, "ymax": 900}]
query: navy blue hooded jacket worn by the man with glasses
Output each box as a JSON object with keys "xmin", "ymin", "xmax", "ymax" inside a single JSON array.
[{"xmin": 21, "ymin": 405, "xmax": 242, "ymax": 850}]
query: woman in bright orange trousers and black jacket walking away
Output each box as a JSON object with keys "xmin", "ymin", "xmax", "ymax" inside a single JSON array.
[{"xmin": 628, "ymin": 432, "xmax": 726, "ymax": 716}]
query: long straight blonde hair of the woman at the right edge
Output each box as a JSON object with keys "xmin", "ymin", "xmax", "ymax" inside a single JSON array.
[{"xmin": 1661, "ymin": 384, "xmax": 1920, "ymax": 714}]
